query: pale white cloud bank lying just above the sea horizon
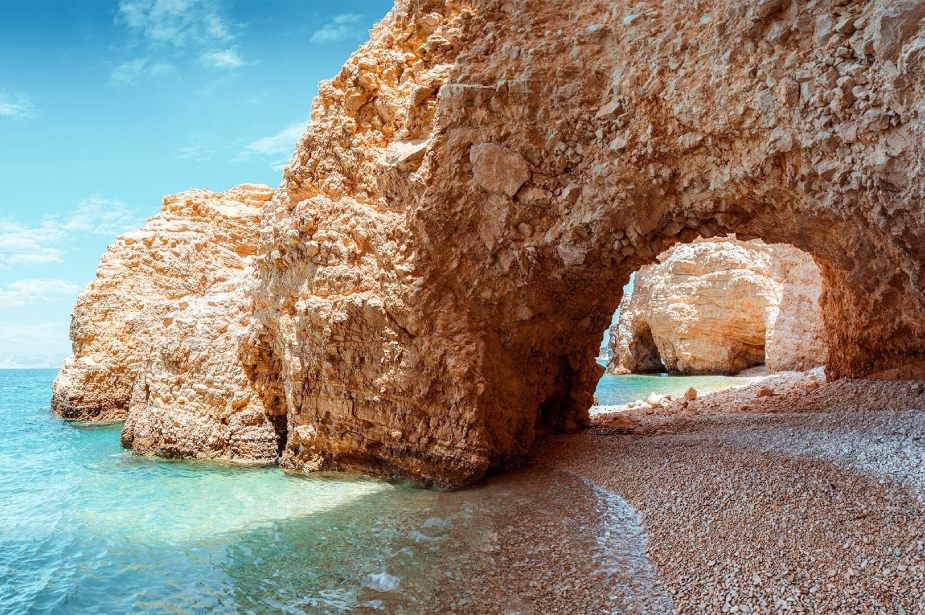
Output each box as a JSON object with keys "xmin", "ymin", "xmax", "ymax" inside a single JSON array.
[{"xmin": 0, "ymin": 322, "xmax": 71, "ymax": 369}]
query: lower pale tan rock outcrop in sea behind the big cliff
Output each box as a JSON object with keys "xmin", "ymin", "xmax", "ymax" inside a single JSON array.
[{"xmin": 52, "ymin": 185, "xmax": 278, "ymax": 460}]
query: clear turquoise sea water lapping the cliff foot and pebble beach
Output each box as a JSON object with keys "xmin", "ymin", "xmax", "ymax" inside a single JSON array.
[{"xmin": 0, "ymin": 370, "xmax": 740, "ymax": 614}]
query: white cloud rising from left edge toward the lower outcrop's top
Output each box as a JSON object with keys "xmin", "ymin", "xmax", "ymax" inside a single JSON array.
[{"xmin": 0, "ymin": 196, "xmax": 141, "ymax": 268}]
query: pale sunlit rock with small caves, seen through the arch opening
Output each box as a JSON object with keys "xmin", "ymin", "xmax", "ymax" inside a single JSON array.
[{"xmin": 608, "ymin": 239, "xmax": 825, "ymax": 374}]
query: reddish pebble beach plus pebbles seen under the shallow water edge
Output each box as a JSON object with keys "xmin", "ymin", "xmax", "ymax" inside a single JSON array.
[{"xmin": 353, "ymin": 372, "xmax": 925, "ymax": 615}]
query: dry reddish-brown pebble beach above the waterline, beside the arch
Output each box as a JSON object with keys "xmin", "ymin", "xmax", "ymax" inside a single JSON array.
[{"xmin": 535, "ymin": 374, "xmax": 925, "ymax": 614}]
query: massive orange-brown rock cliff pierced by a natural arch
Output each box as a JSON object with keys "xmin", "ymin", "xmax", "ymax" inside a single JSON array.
[{"xmin": 59, "ymin": 0, "xmax": 925, "ymax": 484}]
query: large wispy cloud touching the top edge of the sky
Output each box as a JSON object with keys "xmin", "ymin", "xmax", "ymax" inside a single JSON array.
[{"xmin": 110, "ymin": 0, "xmax": 247, "ymax": 84}]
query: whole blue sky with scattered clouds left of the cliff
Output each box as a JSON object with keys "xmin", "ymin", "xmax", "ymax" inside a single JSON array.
[{"xmin": 0, "ymin": 0, "xmax": 391, "ymax": 368}]
